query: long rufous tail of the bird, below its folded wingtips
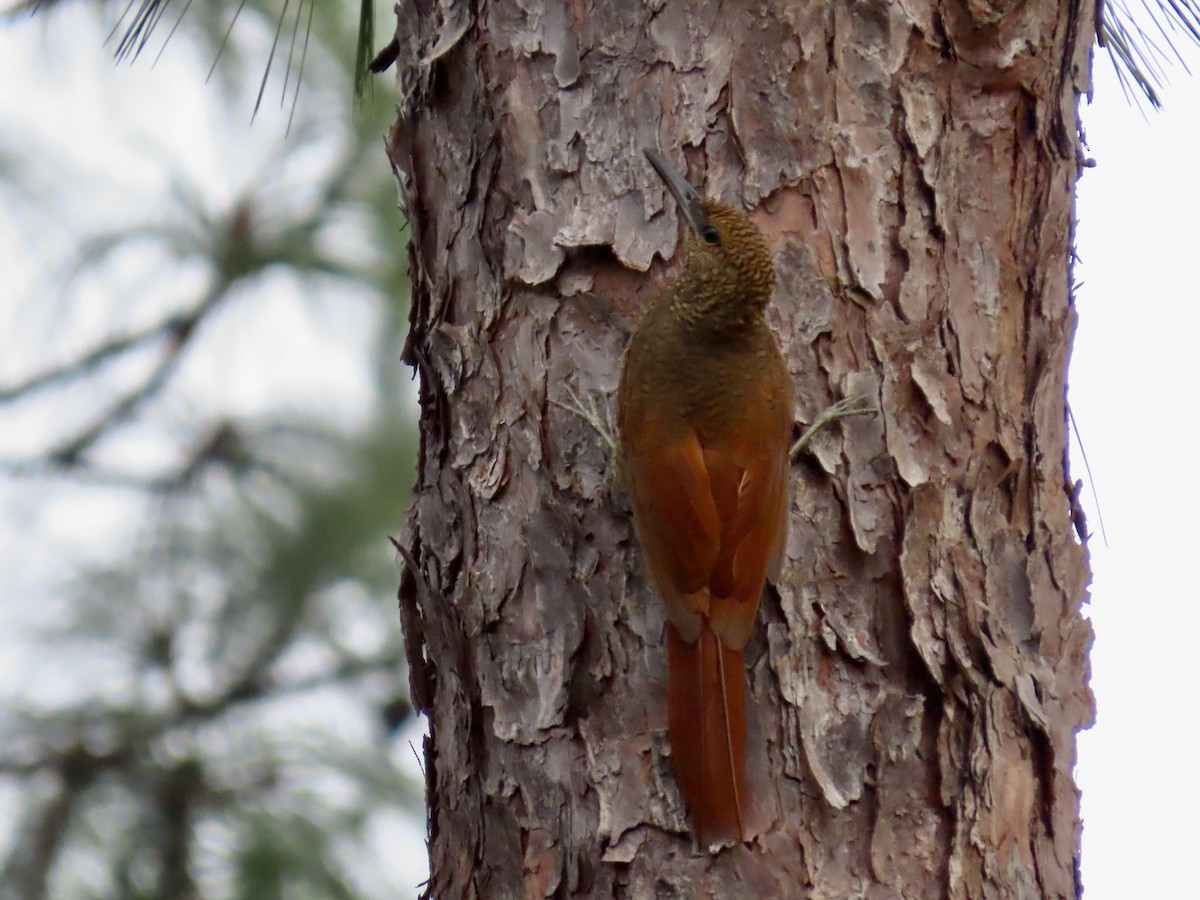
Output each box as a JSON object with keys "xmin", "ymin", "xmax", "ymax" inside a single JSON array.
[{"xmin": 667, "ymin": 617, "xmax": 746, "ymax": 848}]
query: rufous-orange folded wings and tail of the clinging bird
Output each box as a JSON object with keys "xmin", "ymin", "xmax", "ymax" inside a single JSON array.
[{"xmin": 626, "ymin": 430, "xmax": 787, "ymax": 845}]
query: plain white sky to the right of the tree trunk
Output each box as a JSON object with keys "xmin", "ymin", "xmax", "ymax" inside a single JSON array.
[{"xmin": 1070, "ymin": 60, "xmax": 1200, "ymax": 900}]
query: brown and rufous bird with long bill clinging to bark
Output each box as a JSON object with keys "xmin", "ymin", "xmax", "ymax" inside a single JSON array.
[{"xmin": 617, "ymin": 150, "xmax": 794, "ymax": 848}]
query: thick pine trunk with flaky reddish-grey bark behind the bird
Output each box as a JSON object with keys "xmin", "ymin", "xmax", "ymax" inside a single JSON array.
[{"xmin": 389, "ymin": 0, "xmax": 1094, "ymax": 898}]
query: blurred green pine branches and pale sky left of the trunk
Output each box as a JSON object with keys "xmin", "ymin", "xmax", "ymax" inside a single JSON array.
[{"xmin": 0, "ymin": 0, "xmax": 424, "ymax": 898}]
